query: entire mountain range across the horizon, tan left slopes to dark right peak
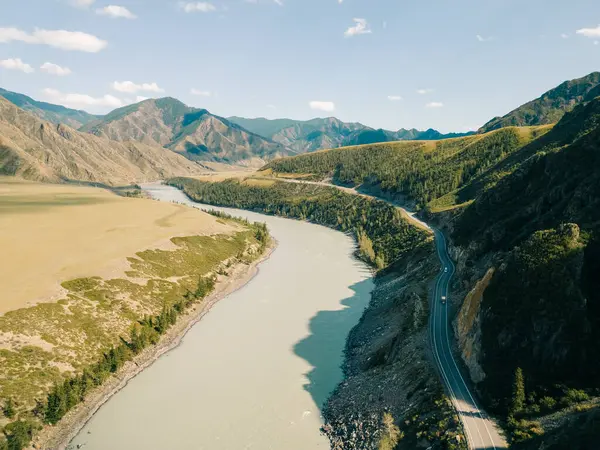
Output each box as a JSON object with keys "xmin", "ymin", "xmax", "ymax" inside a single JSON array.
[{"xmin": 0, "ymin": 72, "xmax": 600, "ymax": 183}]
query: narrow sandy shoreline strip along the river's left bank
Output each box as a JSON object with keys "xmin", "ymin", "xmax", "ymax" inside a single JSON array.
[{"xmin": 30, "ymin": 237, "xmax": 277, "ymax": 450}]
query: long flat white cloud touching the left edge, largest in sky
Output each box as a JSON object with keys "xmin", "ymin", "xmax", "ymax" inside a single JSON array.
[{"xmin": 0, "ymin": 28, "xmax": 108, "ymax": 53}]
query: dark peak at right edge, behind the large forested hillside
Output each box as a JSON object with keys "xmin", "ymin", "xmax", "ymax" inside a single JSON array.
[{"xmin": 479, "ymin": 72, "xmax": 600, "ymax": 133}]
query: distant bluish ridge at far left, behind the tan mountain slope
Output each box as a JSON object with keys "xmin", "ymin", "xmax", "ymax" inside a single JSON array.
[{"xmin": 0, "ymin": 88, "xmax": 99, "ymax": 128}]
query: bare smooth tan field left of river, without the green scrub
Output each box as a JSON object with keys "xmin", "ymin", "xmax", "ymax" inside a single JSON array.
[{"xmin": 0, "ymin": 177, "xmax": 234, "ymax": 314}]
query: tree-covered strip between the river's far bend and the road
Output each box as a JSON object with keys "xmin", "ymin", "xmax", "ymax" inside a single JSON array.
[{"xmin": 168, "ymin": 178, "xmax": 428, "ymax": 268}]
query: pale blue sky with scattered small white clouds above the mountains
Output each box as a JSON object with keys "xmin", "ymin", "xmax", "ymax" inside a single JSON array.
[{"xmin": 0, "ymin": 0, "xmax": 600, "ymax": 132}]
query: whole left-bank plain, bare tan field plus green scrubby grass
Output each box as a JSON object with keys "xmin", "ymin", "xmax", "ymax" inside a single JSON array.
[{"xmin": 0, "ymin": 178, "xmax": 268, "ymax": 412}]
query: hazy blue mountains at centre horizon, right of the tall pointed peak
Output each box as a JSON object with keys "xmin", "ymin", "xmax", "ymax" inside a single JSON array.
[{"xmin": 229, "ymin": 117, "xmax": 472, "ymax": 153}]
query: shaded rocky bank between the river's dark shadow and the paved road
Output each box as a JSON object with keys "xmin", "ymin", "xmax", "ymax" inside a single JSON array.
[{"xmin": 323, "ymin": 244, "xmax": 464, "ymax": 450}]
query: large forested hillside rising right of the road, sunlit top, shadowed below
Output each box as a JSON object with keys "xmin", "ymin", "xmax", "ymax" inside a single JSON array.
[{"xmin": 258, "ymin": 89, "xmax": 600, "ymax": 449}]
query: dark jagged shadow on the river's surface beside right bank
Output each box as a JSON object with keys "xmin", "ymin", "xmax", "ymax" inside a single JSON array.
[{"xmin": 294, "ymin": 278, "xmax": 373, "ymax": 409}]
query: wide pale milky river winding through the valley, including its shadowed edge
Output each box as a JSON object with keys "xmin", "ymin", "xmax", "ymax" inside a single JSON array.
[{"xmin": 70, "ymin": 183, "xmax": 373, "ymax": 450}]
